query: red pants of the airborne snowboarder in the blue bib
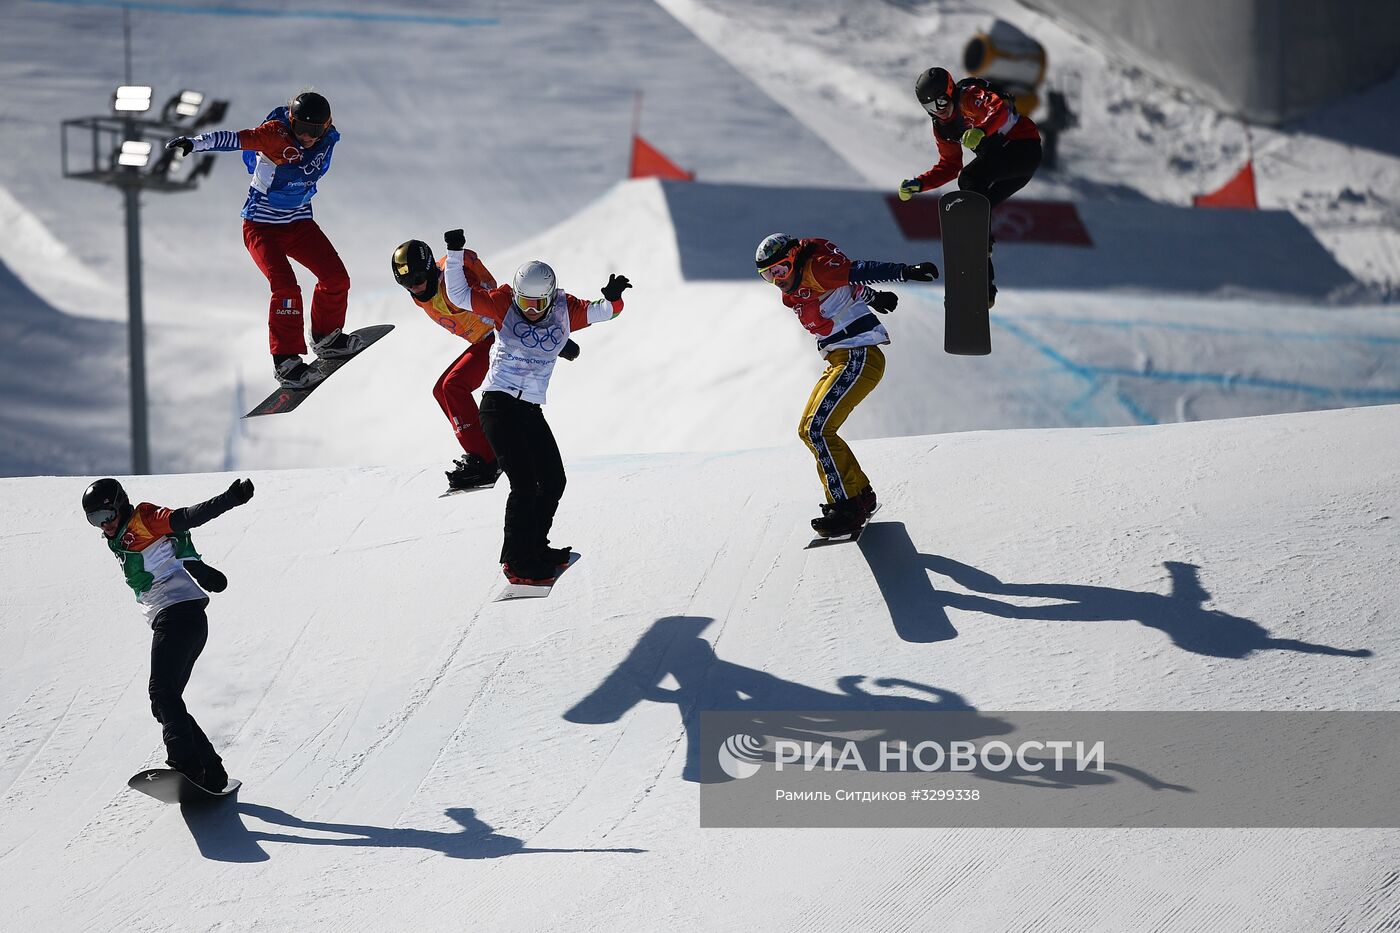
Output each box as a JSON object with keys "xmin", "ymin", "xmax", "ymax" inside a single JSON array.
[{"xmin": 244, "ymin": 220, "xmax": 350, "ymax": 356}]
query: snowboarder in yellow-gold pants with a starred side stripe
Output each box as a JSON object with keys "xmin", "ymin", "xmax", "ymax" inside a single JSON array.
[{"xmin": 755, "ymin": 234, "xmax": 938, "ymax": 538}]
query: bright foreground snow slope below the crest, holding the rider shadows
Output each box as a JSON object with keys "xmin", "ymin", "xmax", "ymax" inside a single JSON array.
[{"xmin": 0, "ymin": 403, "xmax": 1400, "ymax": 932}]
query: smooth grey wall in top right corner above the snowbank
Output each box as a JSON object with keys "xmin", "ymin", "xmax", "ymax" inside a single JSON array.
[{"xmin": 1022, "ymin": 0, "xmax": 1400, "ymax": 123}]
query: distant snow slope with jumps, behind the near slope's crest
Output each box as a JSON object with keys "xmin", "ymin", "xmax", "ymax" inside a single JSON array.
[{"xmin": 0, "ymin": 0, "xmax": 1400, "ymax": 472}]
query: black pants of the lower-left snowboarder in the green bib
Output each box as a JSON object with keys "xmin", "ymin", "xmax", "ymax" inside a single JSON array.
[{"xmin": 151, "ymin": 600, "xmax": 224, "ymax": 780}]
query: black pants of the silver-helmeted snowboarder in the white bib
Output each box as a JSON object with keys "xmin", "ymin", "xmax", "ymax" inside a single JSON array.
[{"xmin": 482, "ymin": 391, "xmax": 566, "ymax": 577}]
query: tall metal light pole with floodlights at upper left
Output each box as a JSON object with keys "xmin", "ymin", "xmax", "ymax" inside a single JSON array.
[{"xmin": 60, "ymin": 11, "xmax": 228, "ymax": 475}]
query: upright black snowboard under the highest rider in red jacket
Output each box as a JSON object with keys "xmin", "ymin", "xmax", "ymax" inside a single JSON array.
[{"xmin": 938, "ymin": 191, "xmax": 991, "ymax": 356}]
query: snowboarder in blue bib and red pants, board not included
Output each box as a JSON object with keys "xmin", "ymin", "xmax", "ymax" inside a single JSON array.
[{"xmin": 165, "ymin": 91, "xmax": 364, "ymax": 388}]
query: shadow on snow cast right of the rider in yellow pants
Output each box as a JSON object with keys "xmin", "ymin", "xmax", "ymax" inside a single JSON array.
[{"xmin": 860, "ymin": 523, "xmax": 1372, "ymax": 658}]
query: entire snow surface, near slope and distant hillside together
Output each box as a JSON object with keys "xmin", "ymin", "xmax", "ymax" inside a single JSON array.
[{"xmin": 0, "ymin": 0, "xmax": 1400, "ymax": 933}]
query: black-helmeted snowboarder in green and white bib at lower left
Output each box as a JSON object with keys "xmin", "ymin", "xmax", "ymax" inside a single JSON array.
[{"xmin": 83, "ymin": 479, "xmax": 253, "ymax": 793}]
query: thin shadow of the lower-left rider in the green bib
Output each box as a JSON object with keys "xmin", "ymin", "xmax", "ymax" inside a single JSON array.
[{"xmin": 181, "ymin": 801, "xmax": 645, "ymax": 862}]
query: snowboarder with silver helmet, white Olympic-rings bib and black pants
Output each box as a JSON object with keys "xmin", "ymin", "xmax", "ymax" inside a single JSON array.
[{"xmin": 442, "ymin": 230, "xmax": 631, "ymax": 586}]
